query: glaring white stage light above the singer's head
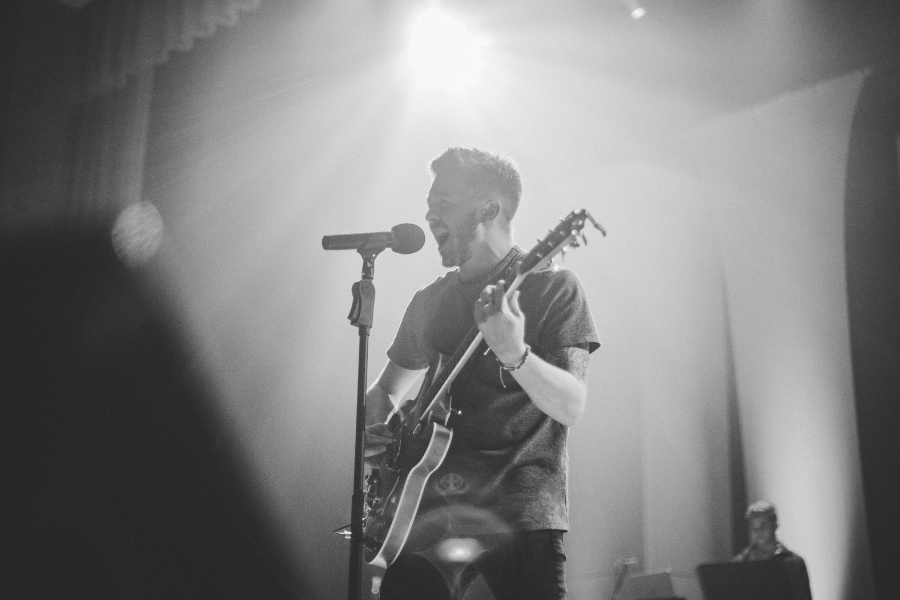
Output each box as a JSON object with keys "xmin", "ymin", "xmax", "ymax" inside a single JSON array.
[{"xmin": 409, "ymin": 8, "xmax": 486, "ymax": 93}]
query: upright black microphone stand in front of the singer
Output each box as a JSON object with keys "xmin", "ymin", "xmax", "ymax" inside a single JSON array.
[{"xmin": 347, "ymin": 247, "xmax": 376, "ymax": 600}]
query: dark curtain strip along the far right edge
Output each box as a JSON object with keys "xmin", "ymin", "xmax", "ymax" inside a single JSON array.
[{"xmin": 845, "ymin": 66, "xmax": 900, "ymax": 598}]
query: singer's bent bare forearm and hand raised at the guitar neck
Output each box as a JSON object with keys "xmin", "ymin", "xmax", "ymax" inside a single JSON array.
[{"xmin": 475, "ymin": 282, "xmax": 589, "ymax": 427}]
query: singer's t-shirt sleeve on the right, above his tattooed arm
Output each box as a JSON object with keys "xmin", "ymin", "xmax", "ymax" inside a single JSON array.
[{"xmin": 539, "ymin": 268, "xmax": 600, "ymax": 352}]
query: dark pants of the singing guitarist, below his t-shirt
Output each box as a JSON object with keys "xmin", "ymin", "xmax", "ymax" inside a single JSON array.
[{"xmin": 381, "ymin": 530, "xmax": 566, "ymax": 600}]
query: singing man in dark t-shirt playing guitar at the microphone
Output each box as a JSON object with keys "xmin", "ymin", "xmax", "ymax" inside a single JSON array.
[{"xmin": 366, "ymin": 148, "xmax": 599, "ymax": 600}]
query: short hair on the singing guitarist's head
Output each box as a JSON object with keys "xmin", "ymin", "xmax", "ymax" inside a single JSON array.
[{"xmin": 431, "ymin": 146, "xmax": 522, "ymax": 221}]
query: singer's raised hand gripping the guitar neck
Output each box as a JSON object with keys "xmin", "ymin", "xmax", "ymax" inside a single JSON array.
[{"xmin": 474, "ymin": 280, "xmax": 525, "ymax": 365}]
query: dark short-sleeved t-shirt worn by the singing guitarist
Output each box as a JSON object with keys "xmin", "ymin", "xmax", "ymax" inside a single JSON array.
[{"xmin": 388, "ymin": 258, "xmax": 599, "ymax": 534}]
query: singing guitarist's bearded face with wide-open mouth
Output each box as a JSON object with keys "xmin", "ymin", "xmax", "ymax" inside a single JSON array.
[{"xmin": 425, "ymin": 174, "xmax": 484, "ymax": 268}]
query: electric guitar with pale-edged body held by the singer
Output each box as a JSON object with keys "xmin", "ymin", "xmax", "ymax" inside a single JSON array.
[{"xmin": 362, "ymin": 209, "xmax": 606, "ymax": 568}]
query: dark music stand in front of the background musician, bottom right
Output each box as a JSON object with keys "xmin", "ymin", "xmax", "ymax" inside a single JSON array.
[{"xmin": 697, "ymin": 560, "xmax": 797, "ymax": 600}]
